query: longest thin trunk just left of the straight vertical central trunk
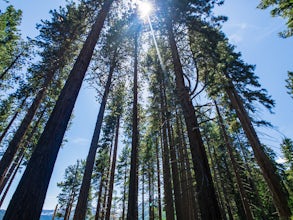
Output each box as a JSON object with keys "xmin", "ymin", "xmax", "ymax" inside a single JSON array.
[{"xmin": 105, "ymin": 116, "xmax": 120, "ymax": 220}]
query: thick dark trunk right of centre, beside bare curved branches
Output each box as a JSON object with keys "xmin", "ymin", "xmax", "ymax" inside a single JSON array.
[{"xmin": 166, "ymin": 15, "xmax": 221, "ymax": 219}]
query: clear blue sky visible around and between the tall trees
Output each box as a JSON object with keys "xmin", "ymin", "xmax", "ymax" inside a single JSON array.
[{"xmin": 0, "ymin": 0, "xmax": 293, "ymax": 209}]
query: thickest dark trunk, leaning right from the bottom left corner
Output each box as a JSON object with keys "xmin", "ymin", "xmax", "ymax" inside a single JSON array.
[{"xmin": 4, "ymin": 0, "xmax": 114, "ymax": 220}]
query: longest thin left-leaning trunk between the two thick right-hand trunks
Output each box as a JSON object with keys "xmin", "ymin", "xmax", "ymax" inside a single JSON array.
[{"xmin": 214, "ymin": 101, "xmax": 253, "ymax": 220}]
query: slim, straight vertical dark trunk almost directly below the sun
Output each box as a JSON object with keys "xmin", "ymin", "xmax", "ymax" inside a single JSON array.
[{"xmin": 127, "ymin": 27, "xmax": 139, "ymax": 220}]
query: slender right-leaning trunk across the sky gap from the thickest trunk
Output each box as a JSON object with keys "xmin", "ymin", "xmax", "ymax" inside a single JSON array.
[{"xmin": 73, "ymin": 48, "xmax": 117, "ymax": 220}]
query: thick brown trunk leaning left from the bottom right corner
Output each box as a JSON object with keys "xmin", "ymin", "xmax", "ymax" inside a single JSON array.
[{"xmin": 226, "ymin": 82, "xmax": 291, "ymax": 219}]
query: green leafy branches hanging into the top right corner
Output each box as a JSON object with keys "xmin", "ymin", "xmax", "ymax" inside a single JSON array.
[{"xmin": 258, "ymin": 0, "xmax": 293, "ymax": 38}]
